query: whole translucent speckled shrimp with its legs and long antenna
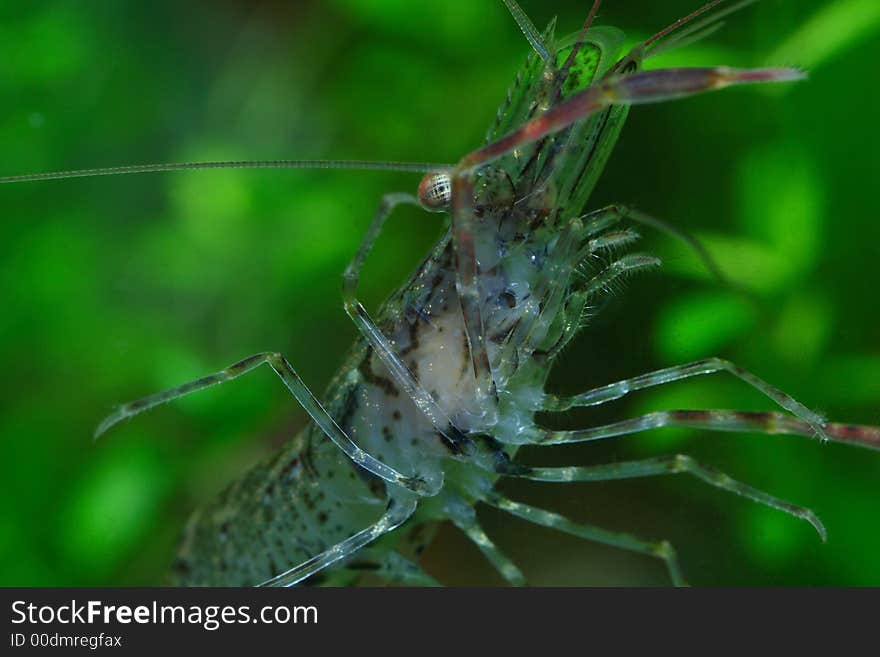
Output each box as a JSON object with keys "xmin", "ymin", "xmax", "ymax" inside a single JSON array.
[{"xmin": 2, "ymin": 0, "xmax": 880, "ymax": 586}]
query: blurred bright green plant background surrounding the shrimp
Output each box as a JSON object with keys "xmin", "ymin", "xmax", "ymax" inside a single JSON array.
[{"xmin": 0, "ymin": 0, "xmax": 880, "ymax": 585}]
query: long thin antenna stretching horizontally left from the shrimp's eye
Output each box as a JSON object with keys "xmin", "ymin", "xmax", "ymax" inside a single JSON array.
[{"xmin": 0, "ymin": 160, "xmax": 452, "ymax": 183}]
